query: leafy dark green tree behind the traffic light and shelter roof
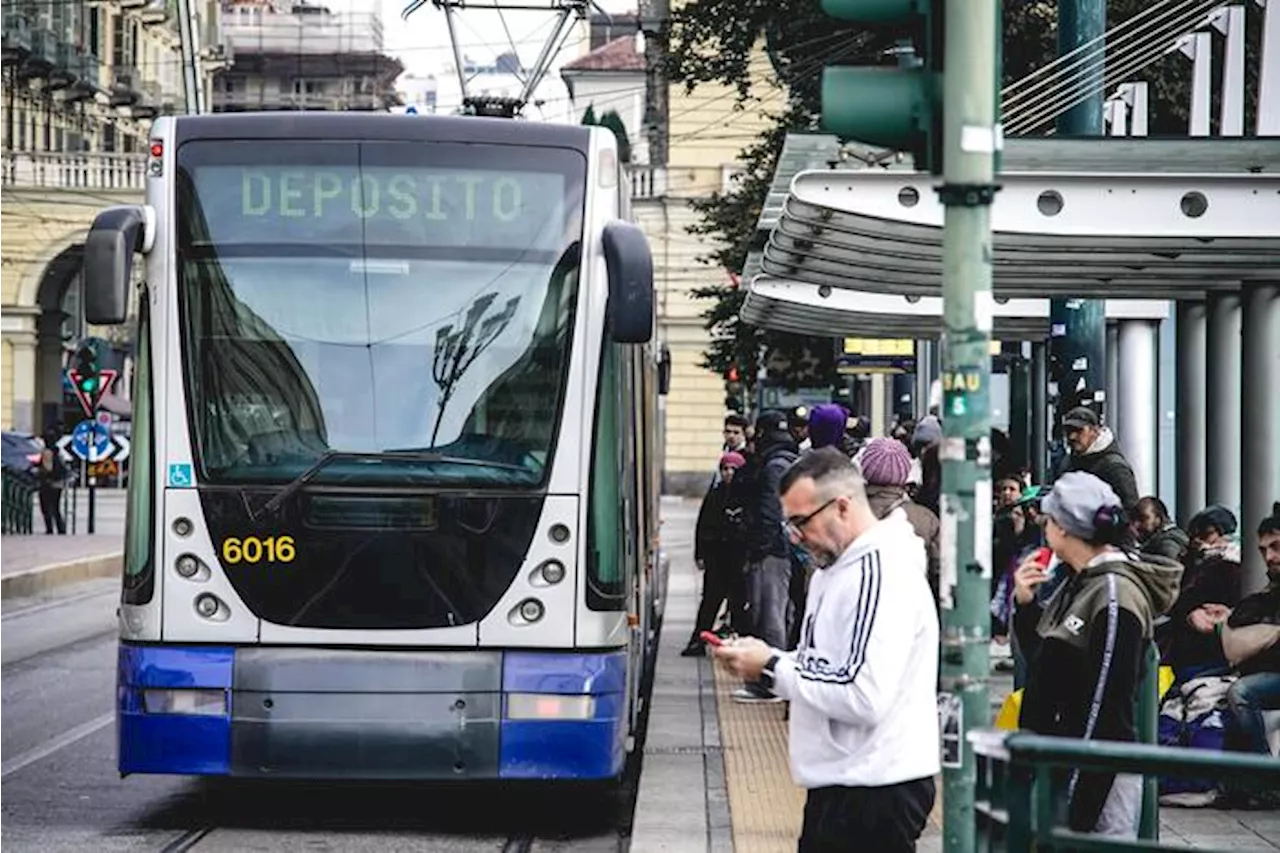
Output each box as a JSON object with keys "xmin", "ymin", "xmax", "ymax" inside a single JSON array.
[{"xmin": 666, "ymin": 0, "xmax": 1261, "ymax": 384}]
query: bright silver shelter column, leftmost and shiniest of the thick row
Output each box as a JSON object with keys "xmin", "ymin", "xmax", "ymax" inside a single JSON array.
[{"xmin": 1112, "ymin": 320, "xmax": 1160, "ymax": 496}]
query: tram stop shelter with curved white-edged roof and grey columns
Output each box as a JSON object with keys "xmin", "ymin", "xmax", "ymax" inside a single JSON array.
[{"xmin": 742, "ymin": 134, "xmax": 1280, "ymax": 587}]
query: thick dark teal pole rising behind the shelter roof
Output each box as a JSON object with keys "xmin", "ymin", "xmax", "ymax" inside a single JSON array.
[{"xmin": 1050, "ymin": 0, "xmax": 1107, "ymax": 445}]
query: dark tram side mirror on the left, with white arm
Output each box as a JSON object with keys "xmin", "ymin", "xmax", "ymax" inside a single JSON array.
[{"xmin": 84, "ymin": 205, "xmax": 155, "ymax": 325}]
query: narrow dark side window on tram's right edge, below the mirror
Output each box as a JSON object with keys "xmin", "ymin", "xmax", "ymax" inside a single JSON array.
[{"xmin": 586, "ymin": 343, "xmax": 626, "ymax": 610}]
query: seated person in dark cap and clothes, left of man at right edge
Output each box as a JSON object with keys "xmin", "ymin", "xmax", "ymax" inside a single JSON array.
[{"xmin": 1156, "ymin": 505, "xmax": 1240, "ymax": 683}]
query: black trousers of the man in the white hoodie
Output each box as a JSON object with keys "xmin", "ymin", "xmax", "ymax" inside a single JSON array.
[{"xmin": 800, "ymin": 777, "xmax": 936, "ymax": 853}]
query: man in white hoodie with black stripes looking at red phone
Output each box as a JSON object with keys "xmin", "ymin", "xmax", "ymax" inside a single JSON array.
[{"xmin": 716, "ymin": 447, "xmax": 941, "ymax": 853}]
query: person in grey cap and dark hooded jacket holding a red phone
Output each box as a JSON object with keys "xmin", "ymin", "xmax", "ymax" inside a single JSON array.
[{"xmin": 1014, "ymin": 471, "xmax": 1183, "ymax": 838}]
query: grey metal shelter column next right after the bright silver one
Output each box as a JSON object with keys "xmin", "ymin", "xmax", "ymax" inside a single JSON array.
[{"xmin": 1176, "ymin": 302, "xmax": 1208, "ymax": 525}]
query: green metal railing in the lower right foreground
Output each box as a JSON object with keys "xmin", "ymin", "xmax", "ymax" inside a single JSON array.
[{"xmin": 969, "ymin": 730, "xmax": 1280, "ymax": 853}]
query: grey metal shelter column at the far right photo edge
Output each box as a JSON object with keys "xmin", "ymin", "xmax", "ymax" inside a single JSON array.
[{"xmin": 1240, "ymin": 284, "xmax": 1280, "ymax": 593}]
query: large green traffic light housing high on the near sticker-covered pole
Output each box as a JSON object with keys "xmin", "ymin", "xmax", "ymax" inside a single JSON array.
[{"xmin": 822, "ymin": 0, "xmax": 945, "ymax": 174}]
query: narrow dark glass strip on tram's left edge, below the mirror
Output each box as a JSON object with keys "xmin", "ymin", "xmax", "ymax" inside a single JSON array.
[{"xmin": 123, "ymin": 292, "xmax": 155, "ymax": 605}]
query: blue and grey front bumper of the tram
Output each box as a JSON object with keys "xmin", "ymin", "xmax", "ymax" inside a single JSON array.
[{"xmin": 116, "ymin": 643, "xmax": 627, "ymax": 780}]
